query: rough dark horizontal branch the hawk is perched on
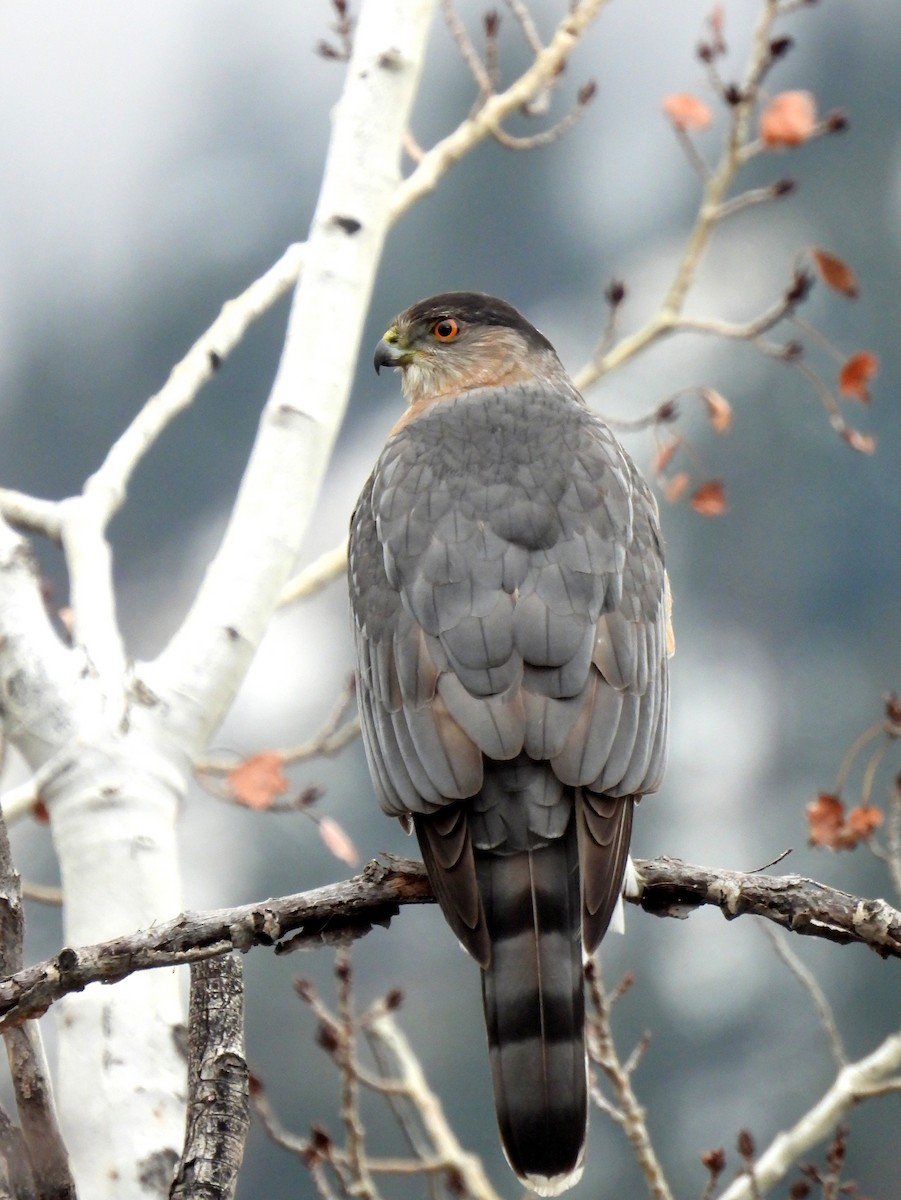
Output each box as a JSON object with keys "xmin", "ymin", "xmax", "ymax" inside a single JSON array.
[{"xmin": 0, "ymin": 857, "xmax": 901, "ymax": 1030}]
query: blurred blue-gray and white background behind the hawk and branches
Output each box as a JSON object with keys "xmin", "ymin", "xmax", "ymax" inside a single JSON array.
[{"xmin": 0, "ymin": 0, "xmax": 901, "ymax": 1200}]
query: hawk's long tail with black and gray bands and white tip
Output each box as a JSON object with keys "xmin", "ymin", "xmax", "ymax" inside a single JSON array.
[{"xmin": 475, "ymin": 820, "xmax": 588, "ymax": 1195}]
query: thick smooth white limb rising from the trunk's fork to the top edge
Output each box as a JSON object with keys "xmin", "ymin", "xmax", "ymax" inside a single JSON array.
[{"xmin": 144, "ymin": 0, "xmax": 439, "ymax": 757}]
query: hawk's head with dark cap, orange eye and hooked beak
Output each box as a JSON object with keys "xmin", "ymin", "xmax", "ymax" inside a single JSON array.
[{"xmin": 373, "ymin": 292, "xmax": 563, "ymax": 404}]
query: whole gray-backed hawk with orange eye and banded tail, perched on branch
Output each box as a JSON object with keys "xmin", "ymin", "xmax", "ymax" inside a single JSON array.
[{"xmin": 349, "ymin": 292, "xmax": 668, "ymax": 1195}]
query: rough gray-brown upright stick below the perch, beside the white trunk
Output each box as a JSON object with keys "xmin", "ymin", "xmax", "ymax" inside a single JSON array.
[{"xmin": 169, "ymin": 954, "xmax": 251, "ymax": 1200}]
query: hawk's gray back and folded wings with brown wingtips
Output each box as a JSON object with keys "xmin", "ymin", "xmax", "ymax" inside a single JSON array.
[{"xmin": 350, "ymin": 384, "xmax": 668, "ymax": 961}]
